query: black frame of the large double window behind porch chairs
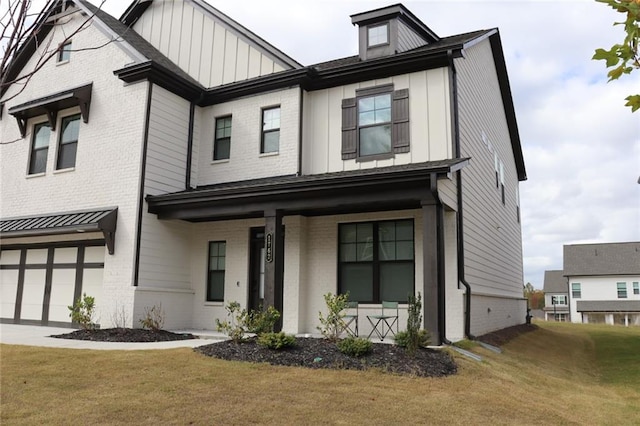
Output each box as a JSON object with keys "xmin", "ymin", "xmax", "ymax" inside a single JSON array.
[{"xmin": 337, "ymin": 218, "xmax": 416, "ymax": 304}]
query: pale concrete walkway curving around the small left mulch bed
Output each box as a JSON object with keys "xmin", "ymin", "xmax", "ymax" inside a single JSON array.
[{"xmin": 0, "ymin": 324, "xmax": 226, "ymax": 350}]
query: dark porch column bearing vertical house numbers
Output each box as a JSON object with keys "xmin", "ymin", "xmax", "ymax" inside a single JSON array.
[{"xmin": 263, "ymin": 210, "xmax": 284, "ymax": 331}]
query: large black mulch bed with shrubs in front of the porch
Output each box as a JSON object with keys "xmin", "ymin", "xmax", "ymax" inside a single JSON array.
[{"xmin": 194, "ymin": 337, "xmax": 457, "ymax": 377}]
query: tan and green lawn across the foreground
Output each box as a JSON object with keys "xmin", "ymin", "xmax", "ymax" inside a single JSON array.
[{"xmin": 0, "ymin": 323, "xmax": 640, "ymax": 425}]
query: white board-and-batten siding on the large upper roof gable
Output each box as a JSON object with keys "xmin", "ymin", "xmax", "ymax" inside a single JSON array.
[{"xmin": 133, "ymin": 0, "xmax": 290, "ymax": 87}]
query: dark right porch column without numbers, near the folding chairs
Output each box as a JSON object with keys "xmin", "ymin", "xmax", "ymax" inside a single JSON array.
[{"xmin": 422, "ymin": 201, "xmax": 440, "ymax": 345}]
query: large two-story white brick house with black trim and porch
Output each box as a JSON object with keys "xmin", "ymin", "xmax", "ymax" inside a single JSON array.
[{"xmin": 0, "ymin": 0, "xmax": 526, "ymax": 343}]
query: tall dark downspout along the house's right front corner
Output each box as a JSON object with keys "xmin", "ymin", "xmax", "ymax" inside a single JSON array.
[{"xmin": 447, "ymin": 51, "xmax": 475, "ymax": 340}]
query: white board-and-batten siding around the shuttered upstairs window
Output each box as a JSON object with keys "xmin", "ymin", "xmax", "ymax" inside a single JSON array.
[{"xmin": 302, "ymin": 68, "xmax": 453, "ymax": 174}]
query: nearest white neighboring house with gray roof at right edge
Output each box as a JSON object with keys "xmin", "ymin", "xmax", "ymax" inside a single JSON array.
[{"xmin": 563, "ymin": 242, "xmax": 640, "ymax": 325}]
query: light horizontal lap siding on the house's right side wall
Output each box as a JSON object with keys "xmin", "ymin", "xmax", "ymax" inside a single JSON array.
[{"xmin": 455, "ymin": 40, "xmax": 524, "ymax": 300}]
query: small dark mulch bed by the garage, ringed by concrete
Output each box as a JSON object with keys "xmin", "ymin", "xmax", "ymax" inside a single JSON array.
[{"xmin": 51, "ymin": 328, "xmax": 198, "ymax": 342}]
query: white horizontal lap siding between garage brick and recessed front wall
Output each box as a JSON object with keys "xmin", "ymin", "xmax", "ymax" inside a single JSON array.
[{"xmin": 138, "ymin": 85, "xmax": 191, "ymax": 292}]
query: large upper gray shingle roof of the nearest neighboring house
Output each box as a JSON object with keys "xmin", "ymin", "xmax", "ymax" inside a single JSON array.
[{"xmin": 564, "ymin": 242, "xmax": 640, "ymax": 276}]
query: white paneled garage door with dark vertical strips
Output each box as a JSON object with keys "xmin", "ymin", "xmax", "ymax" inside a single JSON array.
[{"xmin": 0, "ymin": 241, "xmax": 105, "ymax": 326}]
